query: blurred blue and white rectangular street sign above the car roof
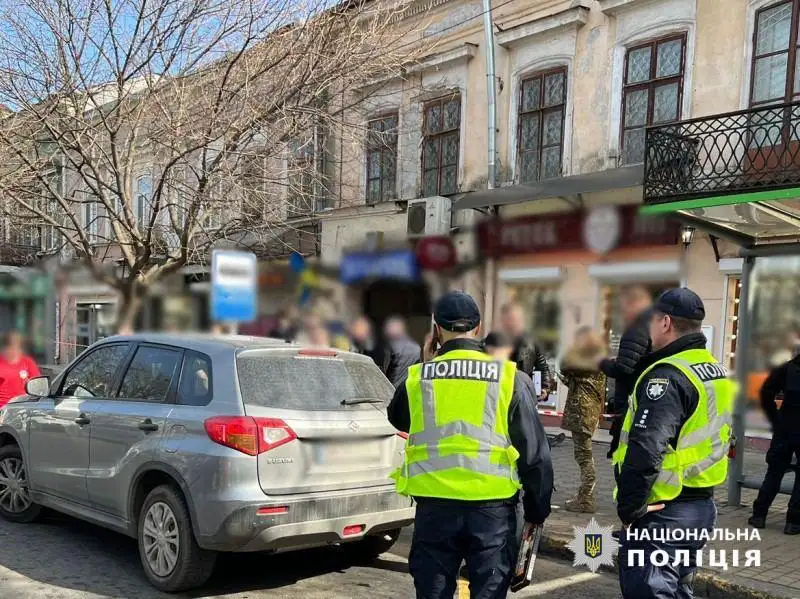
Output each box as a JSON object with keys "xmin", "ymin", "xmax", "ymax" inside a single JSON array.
[{"xmin": 211, "ymin": 250, "xmax": 258, "ymax": 322}]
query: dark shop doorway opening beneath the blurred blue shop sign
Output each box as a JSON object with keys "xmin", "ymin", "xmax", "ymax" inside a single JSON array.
[{"xmin": 361, "ymin": 280, "xmax": 431, "ymax": 344}]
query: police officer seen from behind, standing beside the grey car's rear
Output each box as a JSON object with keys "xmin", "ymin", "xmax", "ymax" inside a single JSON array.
[{"xmin": 389, "ymin": 292, "xmax": 553, "ymax": 599}]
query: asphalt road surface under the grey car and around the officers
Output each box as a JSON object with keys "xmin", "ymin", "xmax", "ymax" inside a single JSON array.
[{"xmin": 0, "ymin": 515, "xmax": 618, "ymax": 599}]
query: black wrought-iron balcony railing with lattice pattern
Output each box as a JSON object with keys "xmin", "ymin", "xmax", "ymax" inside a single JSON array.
[{"xmin": 644, "ymin": 102, "xmax": 800, "ymax": 204}]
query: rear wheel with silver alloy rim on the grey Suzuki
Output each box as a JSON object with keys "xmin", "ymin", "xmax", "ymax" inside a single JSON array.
[{"xmin": 136, "ymin": 485, "xmax": 217, "ymax": 593}]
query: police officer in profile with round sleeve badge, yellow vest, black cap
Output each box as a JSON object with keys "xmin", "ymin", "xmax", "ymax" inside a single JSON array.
[{"xmin": 613, "ymin": 289, "xmax": 736, "ymax": 599}]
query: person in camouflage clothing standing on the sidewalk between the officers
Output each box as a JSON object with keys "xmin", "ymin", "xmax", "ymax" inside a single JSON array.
[{"xmin": 558, "ymin": 327, "xmax": 606, "ymax": 514}]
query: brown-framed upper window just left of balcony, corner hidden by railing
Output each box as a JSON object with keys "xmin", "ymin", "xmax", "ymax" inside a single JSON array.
[{"xmin": 621, "ymin": 33, "xmax": 686, "ymax": 164}]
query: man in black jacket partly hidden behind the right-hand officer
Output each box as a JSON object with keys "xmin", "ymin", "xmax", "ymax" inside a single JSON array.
[{"xmin": 600, "ymin": 285, "xmax": 653, "ymax": 458}]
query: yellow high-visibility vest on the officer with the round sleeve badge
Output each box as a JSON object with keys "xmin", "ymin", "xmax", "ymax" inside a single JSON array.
[{"xmin": 612, "ymin": 349, "xmax": 737, "ymax": 504}]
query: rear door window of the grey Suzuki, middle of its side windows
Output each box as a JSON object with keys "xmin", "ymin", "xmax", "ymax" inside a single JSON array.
[{"xmin": 118, "ymin": 345, "xmax": 181, "ymax": 402}]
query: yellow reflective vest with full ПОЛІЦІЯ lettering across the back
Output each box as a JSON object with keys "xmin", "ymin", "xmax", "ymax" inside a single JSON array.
[{"xmin": 392, "ymin": 350, "xmax": 520, "ymax": 501}]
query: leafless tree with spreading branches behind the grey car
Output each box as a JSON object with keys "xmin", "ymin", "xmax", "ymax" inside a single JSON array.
[{"xmin": 0, "ymin": 0, "xmax": 429, "ymax": 327}]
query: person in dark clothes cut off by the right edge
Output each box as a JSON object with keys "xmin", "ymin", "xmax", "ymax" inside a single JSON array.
[{"xmin": 748, "ymin": 356, "xmax": 800, "ymax": 535}]
